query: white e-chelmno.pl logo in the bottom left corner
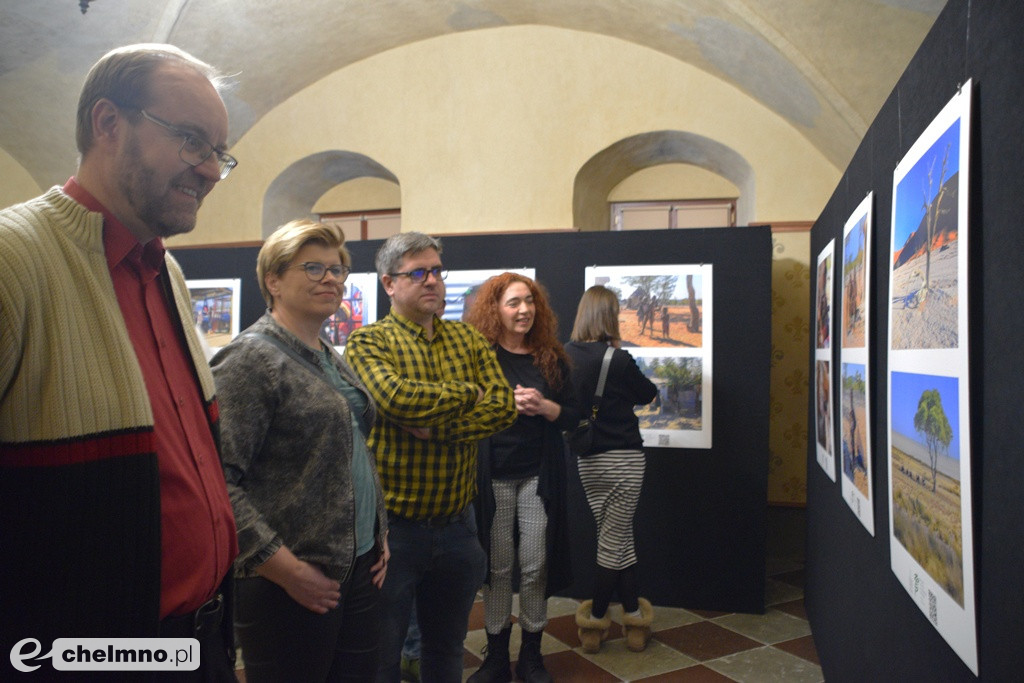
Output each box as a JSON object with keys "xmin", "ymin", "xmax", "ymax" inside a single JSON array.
[{"xmin": 10, "ymin": 638, "xmax": 199, "ymax": 673}]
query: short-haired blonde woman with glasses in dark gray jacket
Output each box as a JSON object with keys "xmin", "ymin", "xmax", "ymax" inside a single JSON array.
[{"xmin": 212, "ymin": 220, "xmax": 389, "ymax": 683}]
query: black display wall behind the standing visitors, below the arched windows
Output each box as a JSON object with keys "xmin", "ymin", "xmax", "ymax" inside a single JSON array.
[{"xmin": 174, "ymin": 226, "xmax": 771, "ymax": 612}]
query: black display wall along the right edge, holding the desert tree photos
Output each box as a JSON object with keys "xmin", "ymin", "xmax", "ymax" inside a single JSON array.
[{"xmin": 805, "ymin": 0, "xmax": 1024, "ymax": 682}]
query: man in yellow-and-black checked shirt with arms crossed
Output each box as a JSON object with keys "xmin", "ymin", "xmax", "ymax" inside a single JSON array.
[{"xmin": 345, "ymin": 232, "xmax": 516, "ymax": 683}]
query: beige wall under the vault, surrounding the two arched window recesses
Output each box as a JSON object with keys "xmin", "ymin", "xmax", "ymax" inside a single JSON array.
[{"xmin": 173, "ymin": 26, "xmax": 840, "ymax": 244}]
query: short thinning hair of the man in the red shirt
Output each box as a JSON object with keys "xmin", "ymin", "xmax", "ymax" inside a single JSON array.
[{"xmin": 75, "ymin": 43, "xmax": 227, "ymax": 155}]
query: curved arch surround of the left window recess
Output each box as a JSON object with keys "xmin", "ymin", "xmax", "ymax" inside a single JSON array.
[{"xmin": 261, "ymin": 150, "xmax": 399, "ymax": 240}]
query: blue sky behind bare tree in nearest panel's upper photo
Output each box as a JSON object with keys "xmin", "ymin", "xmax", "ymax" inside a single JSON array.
[{"xmin": 893, "ymin": 119, "xmax": 961, "ymax": 251}]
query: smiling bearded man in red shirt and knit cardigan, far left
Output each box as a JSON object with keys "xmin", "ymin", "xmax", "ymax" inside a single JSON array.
[{"xmin": 0, "ymin": 45, "xmax": 238, "ymax": 681}]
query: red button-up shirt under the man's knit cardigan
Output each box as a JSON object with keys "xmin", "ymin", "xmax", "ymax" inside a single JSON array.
[{"xmin": 63, "ymin": 178, "xmax": 239, "ymax": 618}]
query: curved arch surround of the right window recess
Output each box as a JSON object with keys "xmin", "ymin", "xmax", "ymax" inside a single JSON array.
[{"xmin": 572, "ymin": 130, "xmax": 755, "ymax": 230}]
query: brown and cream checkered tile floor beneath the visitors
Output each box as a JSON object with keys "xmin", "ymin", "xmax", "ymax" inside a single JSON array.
[{"xmin": 463, "ymin": 560, "xmax": 823, "ymax": 683}]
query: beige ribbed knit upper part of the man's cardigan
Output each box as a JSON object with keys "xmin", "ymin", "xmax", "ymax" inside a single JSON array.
[{"xmin": 0, "ymin": 187, "xmax": 216, "ymax": 450}]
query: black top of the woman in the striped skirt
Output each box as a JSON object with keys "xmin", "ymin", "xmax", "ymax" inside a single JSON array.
[{"xmin": 565, "ymin": 342, "xmax": 657, "ymax": 455}]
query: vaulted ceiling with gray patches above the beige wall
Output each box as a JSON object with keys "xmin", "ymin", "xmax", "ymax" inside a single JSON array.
[{"xmin": 0, "ymin": 0, "xmax": 945, "ymax": 187}]
